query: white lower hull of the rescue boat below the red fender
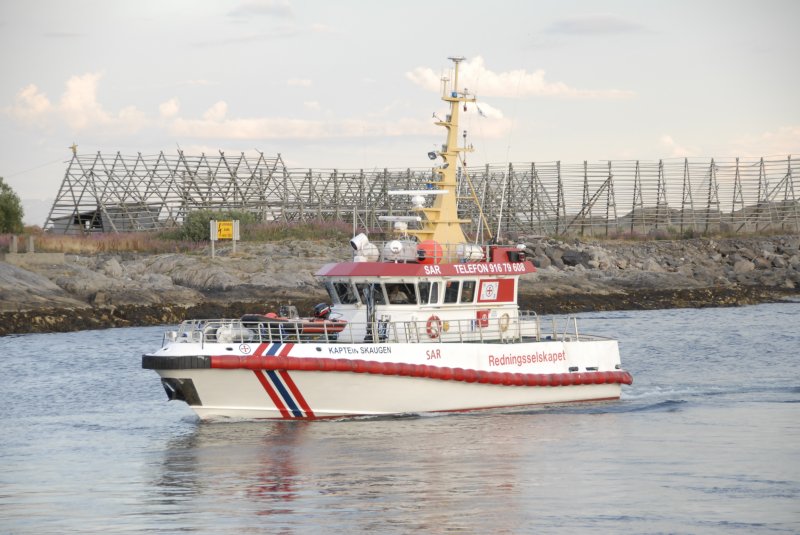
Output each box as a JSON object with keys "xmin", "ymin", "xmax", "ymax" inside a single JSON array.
[{"xmin": 164, "ymin": 370, "xmax": 620, "ymax": 419}]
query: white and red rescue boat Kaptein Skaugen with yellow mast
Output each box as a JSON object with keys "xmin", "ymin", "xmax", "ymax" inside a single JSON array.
[{"xmin": 142, "ymin": 58, "xmax": 632, "ymax": 419}]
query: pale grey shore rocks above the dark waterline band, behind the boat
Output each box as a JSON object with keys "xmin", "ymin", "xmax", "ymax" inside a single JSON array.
[{"xmin": 0, "ymin": 235, "xmax": 800, "ymax": 316}]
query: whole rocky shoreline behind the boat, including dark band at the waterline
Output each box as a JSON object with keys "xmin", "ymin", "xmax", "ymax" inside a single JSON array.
[{"xmin": 0, "ymin": 235, "xmax": 800, "ymax": 336}]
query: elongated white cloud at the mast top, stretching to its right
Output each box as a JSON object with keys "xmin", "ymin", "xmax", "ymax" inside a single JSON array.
[{"xmin": 406, "ymin": 56, "xmax": 635, "ymax": 99}]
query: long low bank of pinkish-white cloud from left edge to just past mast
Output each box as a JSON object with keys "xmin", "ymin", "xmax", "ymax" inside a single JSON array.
[{"xmin": 5, "ymin": 73, "xmax": 512, "ymax": 147}]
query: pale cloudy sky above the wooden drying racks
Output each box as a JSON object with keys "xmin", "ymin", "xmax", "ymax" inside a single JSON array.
[{"xmin": 0, "ymin": 0, "xmax": 800, "ymax": 226}]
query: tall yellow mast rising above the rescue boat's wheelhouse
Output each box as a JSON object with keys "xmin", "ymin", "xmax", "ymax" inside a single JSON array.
[{"xmin": 408, "ymin": 57, "xmax": 475, "ymax": 260}]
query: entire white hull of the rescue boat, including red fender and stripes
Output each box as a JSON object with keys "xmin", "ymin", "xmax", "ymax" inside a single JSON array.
[{"xmin": 145, "ymin": 340, "xmax": 630, "ymax": 419}]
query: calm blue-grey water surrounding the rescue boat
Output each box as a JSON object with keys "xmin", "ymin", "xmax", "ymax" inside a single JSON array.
[{"xmin": 0, "ymin": 303, "xmax": 800, "ymax": 534}]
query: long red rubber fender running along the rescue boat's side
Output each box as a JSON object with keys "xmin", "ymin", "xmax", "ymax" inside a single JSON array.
[{"xmin": 211, "ymin": 355, "xmax": 633, "ymax": 386}]
